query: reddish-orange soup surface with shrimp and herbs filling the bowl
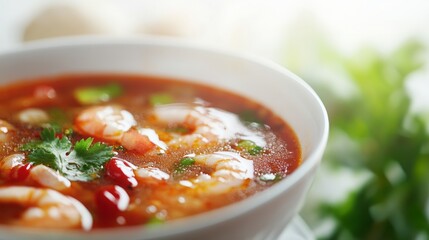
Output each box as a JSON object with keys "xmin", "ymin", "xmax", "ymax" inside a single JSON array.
[{"xmin": 0, "ymin": 75, "xmax": 301, "ymax": 230}]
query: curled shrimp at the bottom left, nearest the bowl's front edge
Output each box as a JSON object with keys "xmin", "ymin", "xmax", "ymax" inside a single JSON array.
[{"xmin": 0, "ymin": 186, "xmax": 92, "ymax": 230}]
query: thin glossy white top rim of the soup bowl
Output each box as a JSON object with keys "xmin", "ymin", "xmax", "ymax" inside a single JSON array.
[{"xmin": 0, "ymin": 36, "xmax": 329, "ymax": 238}]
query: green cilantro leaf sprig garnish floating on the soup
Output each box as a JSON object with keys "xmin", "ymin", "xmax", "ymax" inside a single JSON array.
[{"xmin": 21, "ymin": 128, "xmax": 114, "ymax": 181}]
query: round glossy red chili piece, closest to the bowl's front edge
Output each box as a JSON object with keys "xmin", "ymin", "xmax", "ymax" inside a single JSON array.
[{"xmin": 95, "ymin": 185, "xmax": 130, "ymax": 216}]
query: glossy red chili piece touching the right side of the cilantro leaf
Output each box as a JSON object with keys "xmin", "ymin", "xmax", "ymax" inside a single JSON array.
[{"xmin": 106, "ymin": 157, "xmax": 138, "ymax": 188}]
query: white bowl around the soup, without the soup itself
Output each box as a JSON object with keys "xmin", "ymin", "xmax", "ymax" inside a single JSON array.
[{"xmin": 0, "ymin": 39, "xmax": 329, "ymax": 240}]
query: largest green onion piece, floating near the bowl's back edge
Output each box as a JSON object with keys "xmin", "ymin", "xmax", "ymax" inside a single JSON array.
[{"xmin": 74, "ymin": 83, "xmax": 123, "ymax": 104}]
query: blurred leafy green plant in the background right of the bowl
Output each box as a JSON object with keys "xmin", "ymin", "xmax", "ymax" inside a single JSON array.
[{"xmin": 284, "ymin": 41, "xmax": 429, "ymax": 240}]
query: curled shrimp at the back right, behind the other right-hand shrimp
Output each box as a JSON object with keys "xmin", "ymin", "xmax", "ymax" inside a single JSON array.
[{"xmin": 153, "ymin": 104, "xmax": 266, "ymax": 146}]
